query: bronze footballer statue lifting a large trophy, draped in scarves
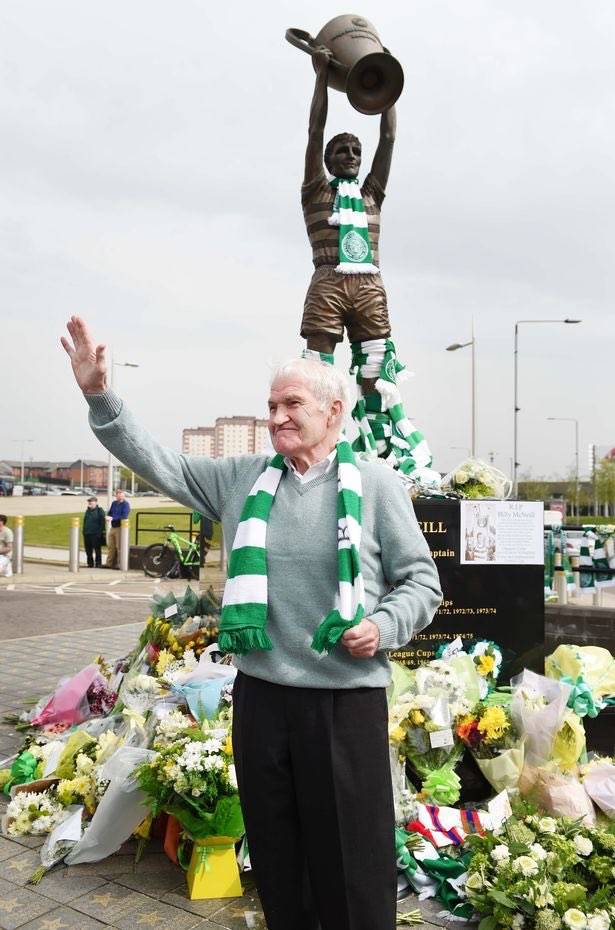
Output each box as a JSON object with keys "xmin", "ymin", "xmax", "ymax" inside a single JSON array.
[{"xmin": 286, "ymin": 15, "xmax": 439, "ymax": 484}]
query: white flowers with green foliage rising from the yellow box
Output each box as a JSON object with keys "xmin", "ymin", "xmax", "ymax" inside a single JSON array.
[{"xmin": 136, "ymin": 727, "xmax": 244, "ymax": 840}]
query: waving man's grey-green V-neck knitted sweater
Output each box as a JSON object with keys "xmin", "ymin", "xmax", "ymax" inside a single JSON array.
[{"xmin": 86, "ymin": 391, "xmax": 442, "ymax": 688}]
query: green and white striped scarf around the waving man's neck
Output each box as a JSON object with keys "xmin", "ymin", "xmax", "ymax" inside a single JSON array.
[{"xmin": 218, "ymin": 439, "xmax": 365, "ymax": 655}]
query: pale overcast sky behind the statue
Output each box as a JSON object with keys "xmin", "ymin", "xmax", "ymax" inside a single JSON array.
[{"xmin": 0, "ymin": 0, "xmax": 615, "ymax": 475}]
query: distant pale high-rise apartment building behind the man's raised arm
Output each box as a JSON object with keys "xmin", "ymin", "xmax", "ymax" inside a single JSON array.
[{"xmin": 182, "ymin": 417, "xmax": 269, "ymax": 458}]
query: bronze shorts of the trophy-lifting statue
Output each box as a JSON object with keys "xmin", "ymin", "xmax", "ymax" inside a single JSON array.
[{"xmin": 301, "ymin": 265, "xmax": 391, "ymax": 342}]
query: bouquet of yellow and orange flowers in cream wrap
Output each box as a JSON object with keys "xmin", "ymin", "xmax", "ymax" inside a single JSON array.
[{"xmin": 455, "ymin": 704, "xmax": 524, "ymax": 792}]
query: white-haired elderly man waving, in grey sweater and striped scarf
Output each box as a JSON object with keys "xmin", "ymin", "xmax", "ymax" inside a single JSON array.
[{"xmin": 62, "ymin": 317, "xmax": 441, "ymax": 930}]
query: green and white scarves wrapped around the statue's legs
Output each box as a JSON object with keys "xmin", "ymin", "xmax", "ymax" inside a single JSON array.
[{"xmin": 350, "ymin": 339, "xmax": 440, "ymax": 484}]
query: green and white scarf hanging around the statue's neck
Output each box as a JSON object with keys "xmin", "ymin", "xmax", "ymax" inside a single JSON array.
[{"xmin": 328, "ymin": 178, "xmax": 379, "ymax": 274}]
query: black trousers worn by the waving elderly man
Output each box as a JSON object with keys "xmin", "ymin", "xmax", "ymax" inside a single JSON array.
[{"xmin": 233, "ymin": 672, "xmax": 397, "ymax": 930}]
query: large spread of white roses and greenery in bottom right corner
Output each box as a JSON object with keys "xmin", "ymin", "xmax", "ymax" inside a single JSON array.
[{"xmin": 465, "ymin": 808, "xmax": 615, "ymax": 930}]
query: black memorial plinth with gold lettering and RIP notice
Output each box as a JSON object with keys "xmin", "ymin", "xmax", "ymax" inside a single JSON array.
[{"xmin": 389, "ymin": 500, "xmax": 544, "ymax": 682}]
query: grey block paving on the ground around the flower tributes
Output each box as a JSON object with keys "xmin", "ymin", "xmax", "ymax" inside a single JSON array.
[{"xmin": 0, "ymin": 623, "xmax": 443, "ymax": 930}]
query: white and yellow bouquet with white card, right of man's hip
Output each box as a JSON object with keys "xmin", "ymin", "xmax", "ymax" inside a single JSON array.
[{"xmin": 389, "ymin": 659, "xmax": 471, "ymax": 805}]
